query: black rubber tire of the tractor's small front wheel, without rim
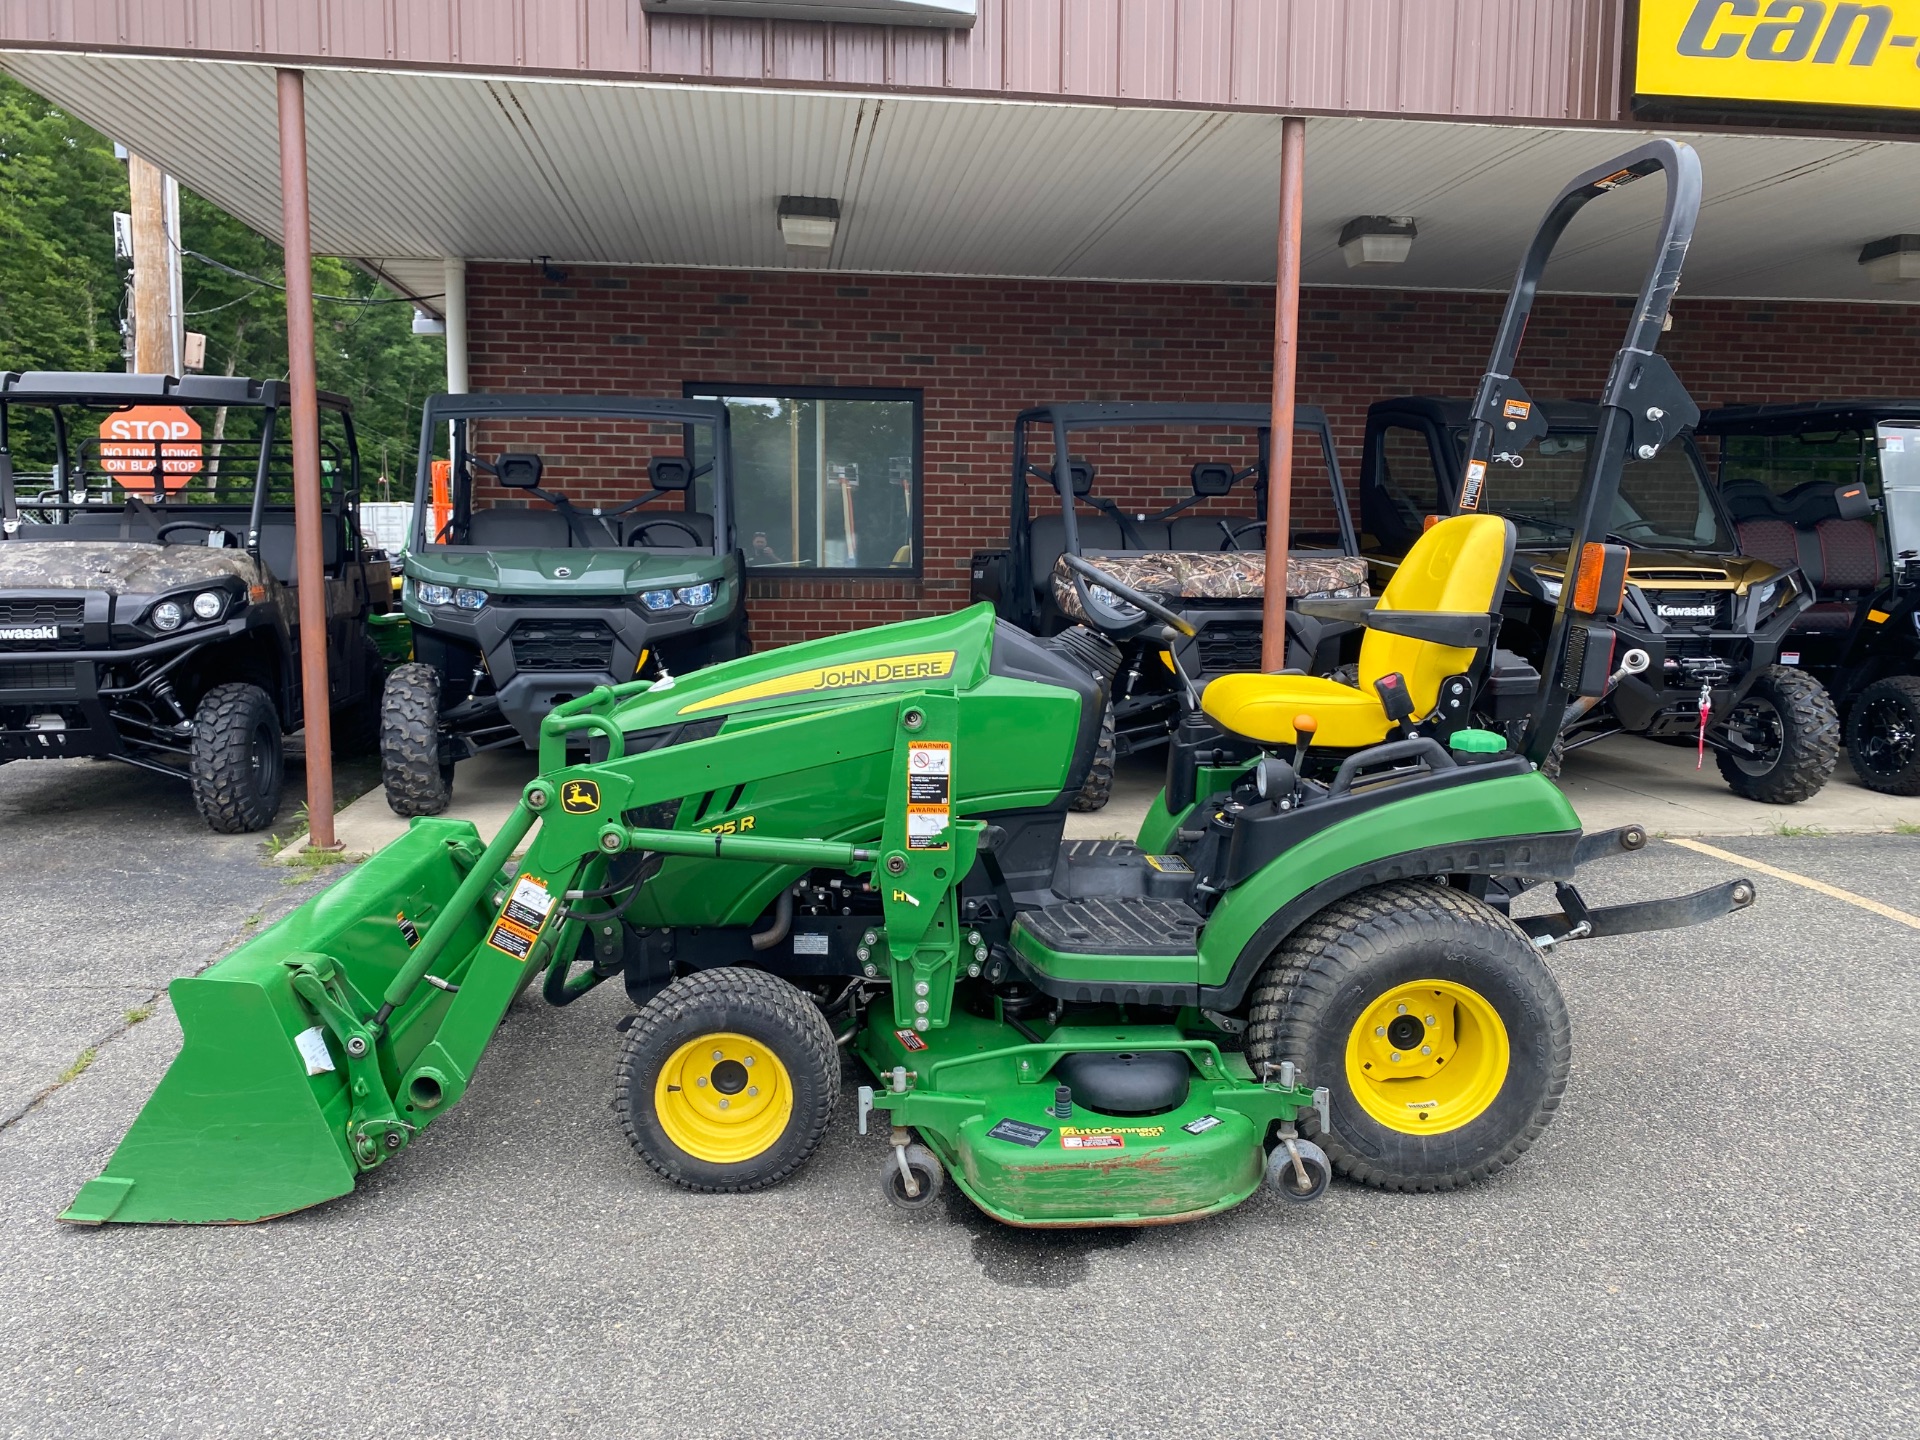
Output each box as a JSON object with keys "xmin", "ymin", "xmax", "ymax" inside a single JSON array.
[{"xmin": 614, "ymin": 966, "xmax": 841, "ymax": 1194}]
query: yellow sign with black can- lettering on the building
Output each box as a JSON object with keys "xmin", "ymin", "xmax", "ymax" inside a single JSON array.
[{"xmin": 1634, "ymin": 0, "xmax": 1920, "ymax": 109}]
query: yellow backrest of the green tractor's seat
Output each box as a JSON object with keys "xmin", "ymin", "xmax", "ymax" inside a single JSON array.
[{"xmin": 1359, "ymin": 515, "xmax": 1515, "ymax": 716}]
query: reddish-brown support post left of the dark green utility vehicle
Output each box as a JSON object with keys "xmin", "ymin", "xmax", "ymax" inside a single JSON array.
[{"xmin": 276, "ymin": 69, "xmax": 340, "ymax": 851}]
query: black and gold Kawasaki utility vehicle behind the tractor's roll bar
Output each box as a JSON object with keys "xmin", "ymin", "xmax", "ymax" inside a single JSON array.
[{"xmin": 1359, "ymin": 395, "xmax": 1839, "ymax": 804}]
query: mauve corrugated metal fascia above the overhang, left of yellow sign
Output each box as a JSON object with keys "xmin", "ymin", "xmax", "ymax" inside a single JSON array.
[{"xmin": 0, "ymin": 0, "xmax": 1624, "ymax": 121}]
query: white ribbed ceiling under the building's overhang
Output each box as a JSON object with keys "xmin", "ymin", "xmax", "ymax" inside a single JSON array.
[{"xmin": 11, "ymin": 52, "xmax": 1920, "ymax": 301}]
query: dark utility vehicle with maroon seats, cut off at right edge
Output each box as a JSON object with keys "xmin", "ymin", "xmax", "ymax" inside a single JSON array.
[{"xmin": 1699, "ymin": 399, "xmax": 1920, "ymax": 795}]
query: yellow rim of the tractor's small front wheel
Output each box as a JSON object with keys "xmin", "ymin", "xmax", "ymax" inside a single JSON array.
[{"xmin": 653, "ymin": 1031, "xmax": 793, "ymax": 1165}]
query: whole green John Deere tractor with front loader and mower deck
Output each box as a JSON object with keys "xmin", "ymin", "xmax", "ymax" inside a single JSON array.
[{"xmin": 65, "ymin": 142, "xmax": 1753, "ymax": 1225}]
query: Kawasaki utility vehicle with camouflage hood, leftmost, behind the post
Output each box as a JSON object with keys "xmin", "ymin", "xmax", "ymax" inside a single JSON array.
[{"xmin": 0, "ymin": 372, "xmax": 392, "ymax": 833}]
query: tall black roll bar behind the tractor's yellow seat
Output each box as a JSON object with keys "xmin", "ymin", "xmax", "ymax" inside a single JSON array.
[{"xmin": 1457, "ymin": 140, "xmax": 1701, "ymax": 764}]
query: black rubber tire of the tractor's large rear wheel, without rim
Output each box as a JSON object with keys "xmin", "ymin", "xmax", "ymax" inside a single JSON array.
[{"xmin": 1246, "ymin": 881, "xmax": 1572, "ymax": 1190}]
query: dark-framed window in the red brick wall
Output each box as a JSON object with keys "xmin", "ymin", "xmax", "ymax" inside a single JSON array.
[{"xmin": 685, "ymin": 384, "xmax": 920, "ymax": 574}]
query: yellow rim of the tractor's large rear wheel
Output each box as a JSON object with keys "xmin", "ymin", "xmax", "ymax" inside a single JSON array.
[{"xmin": 1346, "ymin": 979, "xmax": 1513, "ymax": 1135}]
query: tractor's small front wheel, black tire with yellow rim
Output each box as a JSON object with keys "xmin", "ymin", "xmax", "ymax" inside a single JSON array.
[{"xmin": 614, "ymin": 966, "xmax": 841, "ymax": 1194}]
